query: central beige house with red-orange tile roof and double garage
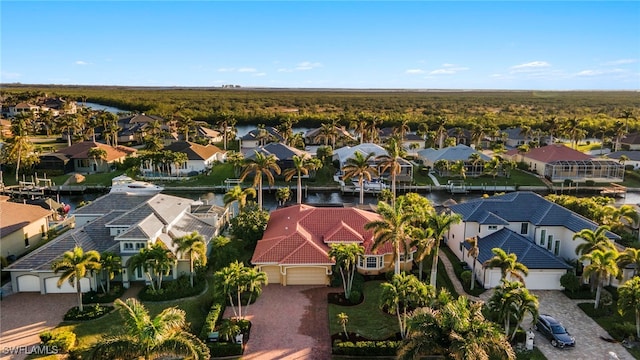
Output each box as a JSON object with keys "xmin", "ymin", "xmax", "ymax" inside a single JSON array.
[{"xmin": 251, "ymin": 205, "xmax": 415, "ymax": 285}]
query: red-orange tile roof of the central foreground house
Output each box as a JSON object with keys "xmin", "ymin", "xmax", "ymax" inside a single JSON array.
[{"xmin": 251, "ymin": 205, "xmax": 404, "ymax": 265}]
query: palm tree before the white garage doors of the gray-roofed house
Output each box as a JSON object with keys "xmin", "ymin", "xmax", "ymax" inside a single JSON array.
[{"xmin": 51, "ymin": 246, "xmax": 100, "ymax": 312}]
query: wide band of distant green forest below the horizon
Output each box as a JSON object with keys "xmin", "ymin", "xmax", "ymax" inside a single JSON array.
[{"xmin": 0, "ymin": 84, "xmax": 640, "ymax": 135}]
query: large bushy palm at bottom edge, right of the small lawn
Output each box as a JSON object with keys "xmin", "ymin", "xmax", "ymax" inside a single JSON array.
[{"xmin": 398, "ymin": 296, "xmax": 516, "ymax": 360}]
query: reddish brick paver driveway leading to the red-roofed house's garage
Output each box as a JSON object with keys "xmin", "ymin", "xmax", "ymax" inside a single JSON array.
[{"xmin": 225, "ymin": 284, "xmax": 332, "ymax": 360}]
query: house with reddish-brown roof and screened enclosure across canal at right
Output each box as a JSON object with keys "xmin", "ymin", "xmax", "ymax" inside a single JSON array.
[{"xmin": 504, "ymin": 144, "xmax": 624, "ymax": 183}]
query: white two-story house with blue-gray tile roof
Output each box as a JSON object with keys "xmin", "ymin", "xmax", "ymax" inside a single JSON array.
[{"xmin": 446, "ymin": 192, "xmax": 620, "ymax": 290}]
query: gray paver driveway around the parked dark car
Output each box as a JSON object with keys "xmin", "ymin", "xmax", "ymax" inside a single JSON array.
[{"xmin": 525, "ymin": 290, "xmax": 633, "ymax": 360}]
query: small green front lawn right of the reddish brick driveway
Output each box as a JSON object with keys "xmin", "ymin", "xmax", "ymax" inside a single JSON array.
[{"xmin": 329, "ymin": 281, "xmax": 399, "ymax": 340}]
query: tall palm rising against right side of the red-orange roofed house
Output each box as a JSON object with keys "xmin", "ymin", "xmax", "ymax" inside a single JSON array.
[{"xmin": 364, "ymin": 198, "xmax": 415, "ymax": 274}]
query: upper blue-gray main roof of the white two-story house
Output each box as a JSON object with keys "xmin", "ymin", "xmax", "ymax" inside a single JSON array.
[{"xmin": 450, "ymin": 191, "xmax": 620, "ymax": 240}]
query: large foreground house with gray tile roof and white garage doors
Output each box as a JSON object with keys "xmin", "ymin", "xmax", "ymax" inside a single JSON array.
[{"xmin": 5, "ymin": 193, "xmax": 226, "ymax": 294}]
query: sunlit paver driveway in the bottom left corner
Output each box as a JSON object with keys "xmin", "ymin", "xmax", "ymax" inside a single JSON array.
[{"xmin": 0, "ymin": 293, "xmax": 78, "ymax": 360}]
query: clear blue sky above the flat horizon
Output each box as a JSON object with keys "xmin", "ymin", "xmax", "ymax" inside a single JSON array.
[{"xmin": 0, "ymin": 0, "xmax": 640, "ymax": 90}]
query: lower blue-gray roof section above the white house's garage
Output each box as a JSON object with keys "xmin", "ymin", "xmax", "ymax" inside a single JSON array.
[{"xmin": 464, "ymin": 229, "xmax": 571, "ymax": 269}]
